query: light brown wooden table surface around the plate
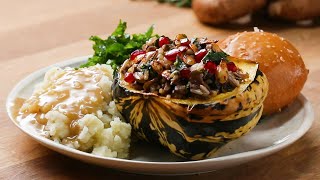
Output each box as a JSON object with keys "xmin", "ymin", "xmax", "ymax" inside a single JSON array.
[{"xmin": 0, "ymin": 0, "xmax": 320, "ymax": 179}]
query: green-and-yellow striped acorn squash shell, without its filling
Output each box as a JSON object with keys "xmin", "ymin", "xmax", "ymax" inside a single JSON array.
[{"xmin": 113, "ymin": 56, "xmax": 268, "ymax": 160}]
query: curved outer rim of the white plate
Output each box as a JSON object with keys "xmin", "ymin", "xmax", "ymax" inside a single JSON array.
[{"xmin": 6, "ymin": 55, "xmax": 314, "ymax": 167}]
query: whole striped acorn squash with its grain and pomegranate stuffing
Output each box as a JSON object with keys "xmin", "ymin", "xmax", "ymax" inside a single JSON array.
[{"xmin": 113, "ymin": 34, "xmax": 268, "ymax": 160}]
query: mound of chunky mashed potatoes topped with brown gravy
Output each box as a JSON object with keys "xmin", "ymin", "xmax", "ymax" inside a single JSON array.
[{"xmin": 19, "ymin": 65, "xmax": 131, "ymax": 158}]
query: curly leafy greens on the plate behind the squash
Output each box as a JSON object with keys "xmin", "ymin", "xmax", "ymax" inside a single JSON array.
[{"xmin": 80, "ymin": 20, "xmax": 158, "ymax": 69}]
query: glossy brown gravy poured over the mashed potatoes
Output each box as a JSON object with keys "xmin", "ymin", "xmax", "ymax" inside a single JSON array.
[{"xmin": 12, "ymin": 68, "xmax": 104, "ymax": 139}]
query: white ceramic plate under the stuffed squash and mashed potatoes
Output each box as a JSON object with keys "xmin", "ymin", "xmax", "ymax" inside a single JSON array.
[{"xmin": 6, "ymin": 57, "xmax": 314, "ymax": 174}]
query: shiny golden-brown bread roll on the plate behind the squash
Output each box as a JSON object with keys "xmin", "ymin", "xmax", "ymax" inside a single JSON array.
[{"xmin": 218, "ymin": 32, "xmax": 309, "ymax": 115}]
